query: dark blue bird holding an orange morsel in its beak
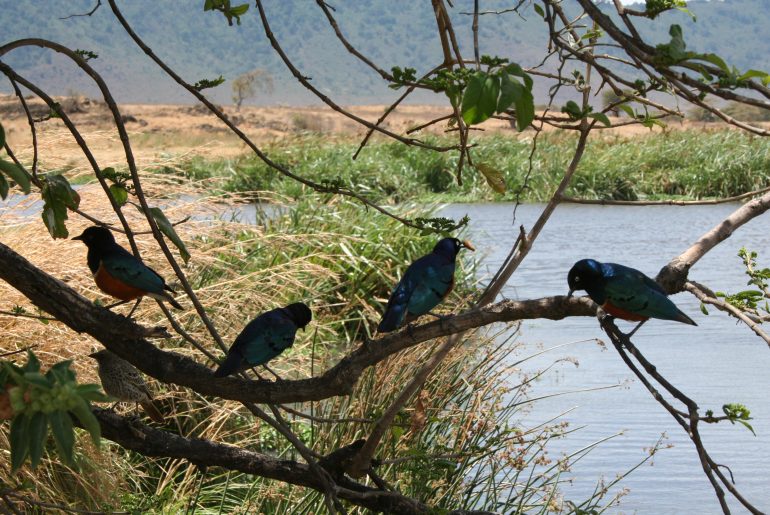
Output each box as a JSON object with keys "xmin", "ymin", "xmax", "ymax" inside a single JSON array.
[{"xmin": 377, "ymin": 238, "xmax": 476, "ymax": 333}]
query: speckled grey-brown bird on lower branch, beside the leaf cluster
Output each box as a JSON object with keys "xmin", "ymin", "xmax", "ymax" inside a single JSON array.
[{"xmin": 89, "ymin": 349, "xmax": 163, "ymax": 424}]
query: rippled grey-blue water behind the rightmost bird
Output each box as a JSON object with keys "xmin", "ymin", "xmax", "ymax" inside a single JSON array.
[{"xmin": 441, "ymin": 204, "xmax": 770, "ymax": 514}]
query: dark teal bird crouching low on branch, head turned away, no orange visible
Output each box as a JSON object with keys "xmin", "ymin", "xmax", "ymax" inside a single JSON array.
[{"xmin": 214, "ymin": 302, "xmax": 313, "ymax": 377}]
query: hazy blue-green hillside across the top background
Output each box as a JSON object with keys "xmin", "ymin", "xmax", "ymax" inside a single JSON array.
[{"xmin": 0, "ymin": 0, "xmax": 770, "ymax": 104}]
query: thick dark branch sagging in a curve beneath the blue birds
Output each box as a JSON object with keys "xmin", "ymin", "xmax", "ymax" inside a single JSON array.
[{"xmin": 0, "ymin": 243, "xmax": 596, "ymax": 404}]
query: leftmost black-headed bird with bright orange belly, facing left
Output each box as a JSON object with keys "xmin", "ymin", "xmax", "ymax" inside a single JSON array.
[{"xmin": 72, "ymin": 226, "xmax": 182, "ymax": 316}]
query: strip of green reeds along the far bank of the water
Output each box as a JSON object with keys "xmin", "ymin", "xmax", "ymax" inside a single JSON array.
[{"xmin": 174, "ymin": 130, "xmax": 770, "ymax": 203}]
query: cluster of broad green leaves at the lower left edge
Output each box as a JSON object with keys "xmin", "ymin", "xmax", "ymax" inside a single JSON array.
[{"xmin": 0, "ymin": 351, "xmax": 109, "ymax": 470}]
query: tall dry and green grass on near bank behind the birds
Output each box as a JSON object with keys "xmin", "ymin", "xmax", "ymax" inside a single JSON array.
[{"xmin": 0, "ymin": 192, "xmax": 614, "ymax": 513}]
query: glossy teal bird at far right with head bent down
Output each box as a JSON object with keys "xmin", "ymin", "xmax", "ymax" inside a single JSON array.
[{"xmin": 567, "ymin": 259, "xmax": 698, "ymax": 337}]
